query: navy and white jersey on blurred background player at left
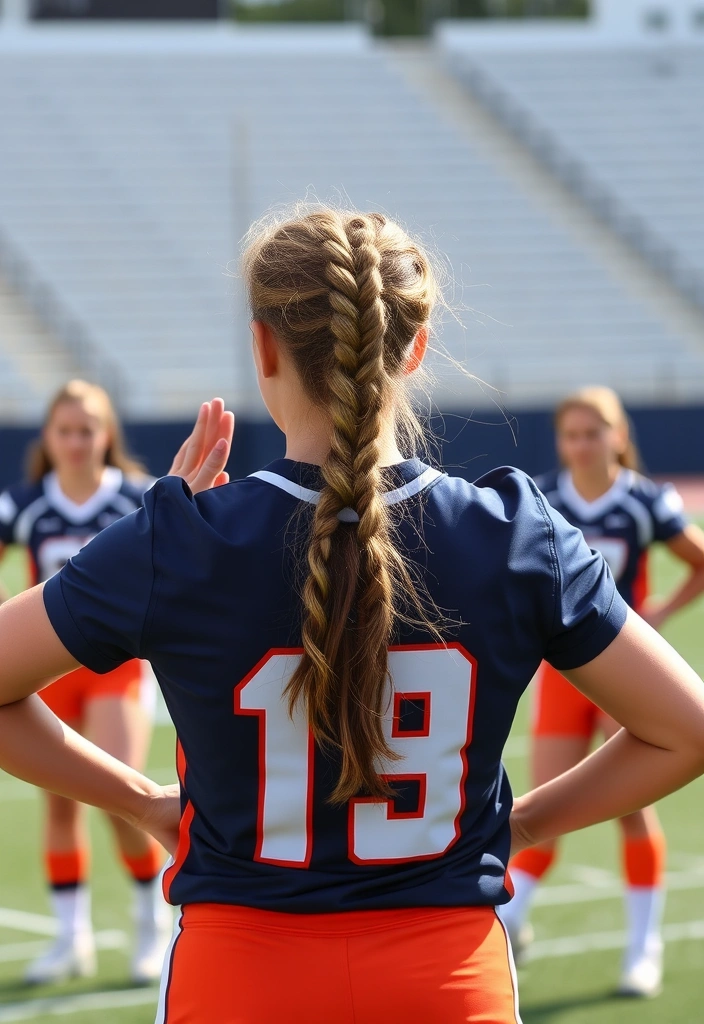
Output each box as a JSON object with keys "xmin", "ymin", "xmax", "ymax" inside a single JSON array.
[{"xmin": 0, "ymin": 466, "xmax": 149, "ymax": 583}]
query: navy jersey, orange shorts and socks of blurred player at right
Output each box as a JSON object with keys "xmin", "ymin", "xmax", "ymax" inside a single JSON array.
[{"xmin": 501, "ymin": 469, "xmax": 687, "ymax": 995}]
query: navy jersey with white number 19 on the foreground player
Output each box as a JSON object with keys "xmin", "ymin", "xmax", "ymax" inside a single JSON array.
[{"xmin": 44, "ymin": 460, "xmax": 626, "ymax": 912}]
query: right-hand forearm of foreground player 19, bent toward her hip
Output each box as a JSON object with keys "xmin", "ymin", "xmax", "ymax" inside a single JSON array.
[{"xmin": 514, "ymin": 729, "xmax": 704, "ymax": 843}]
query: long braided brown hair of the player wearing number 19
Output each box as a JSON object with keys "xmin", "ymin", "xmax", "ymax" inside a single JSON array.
[{"xmin": 244, "ymin": 209, "xmax": 437, "ymax": 802}]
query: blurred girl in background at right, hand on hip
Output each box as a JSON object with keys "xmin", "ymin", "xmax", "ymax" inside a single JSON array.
[{"xmin": 501, "ymin": 387, "xmax": 704, "ymax": 996}]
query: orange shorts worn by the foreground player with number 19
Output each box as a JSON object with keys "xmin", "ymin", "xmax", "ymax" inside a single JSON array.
[{"xmin": 157, "ymin": 903, "xmax": 520, "ymax": 1024}]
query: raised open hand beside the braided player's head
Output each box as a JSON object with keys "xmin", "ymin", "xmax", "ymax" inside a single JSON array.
[{"xmin": 169, "ymin": 398, "xmax": 234, "ymax": 494}]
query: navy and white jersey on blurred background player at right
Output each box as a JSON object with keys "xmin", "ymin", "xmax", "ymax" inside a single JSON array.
[{"xmin": 535, "ymin": 469, "xmax": 687, "ymax": 608}]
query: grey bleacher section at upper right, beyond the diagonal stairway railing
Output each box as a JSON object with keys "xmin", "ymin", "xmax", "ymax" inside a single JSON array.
[{"xmin": 451, "ymin": 45, "xmax": 704, "ymax": 306}]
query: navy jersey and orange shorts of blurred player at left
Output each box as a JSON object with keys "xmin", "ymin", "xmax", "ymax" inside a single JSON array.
[{"xmin": 0, "ymin": 466, "xmax": 146, "ymax": 723}]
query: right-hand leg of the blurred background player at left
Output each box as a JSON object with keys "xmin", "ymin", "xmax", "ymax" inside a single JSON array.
[{"xmin": 86, "ymin": 694, "xmax": 173, "ymax": 983}]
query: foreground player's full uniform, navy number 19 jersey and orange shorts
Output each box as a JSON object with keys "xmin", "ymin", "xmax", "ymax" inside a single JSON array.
[{"xmin": 44, "ymin": 460, "xmax": 626, "ymax": 1024}]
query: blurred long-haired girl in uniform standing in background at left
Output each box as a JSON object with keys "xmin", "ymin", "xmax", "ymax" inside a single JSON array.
[{"xmin": 0, "ymin": 380, "xmax": 171, "ymax": 984}]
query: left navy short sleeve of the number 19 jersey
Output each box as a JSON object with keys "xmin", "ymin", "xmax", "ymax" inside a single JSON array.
[{"xmin": 44, "ymin": 481, "xmax": 159, "ymax": 673}]
